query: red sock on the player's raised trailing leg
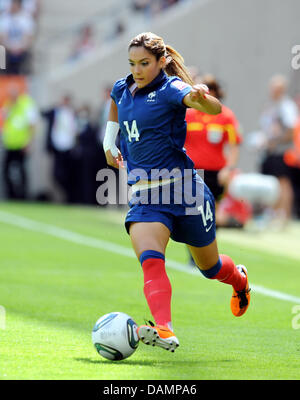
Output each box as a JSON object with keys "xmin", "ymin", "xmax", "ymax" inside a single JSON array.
[{"xmin": 213, "ymin": 254, "xmax": 247, "ymax": 291}]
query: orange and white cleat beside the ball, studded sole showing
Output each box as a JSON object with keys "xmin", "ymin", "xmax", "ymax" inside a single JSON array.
[{"xmin": 137, "ymin": 321, "xmax": 179, "ymax": 353}]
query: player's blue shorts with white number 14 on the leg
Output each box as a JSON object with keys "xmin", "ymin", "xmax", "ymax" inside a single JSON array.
[{"xmin": 125, "ymin": 181, "xmax": 216, "ymax": 247}]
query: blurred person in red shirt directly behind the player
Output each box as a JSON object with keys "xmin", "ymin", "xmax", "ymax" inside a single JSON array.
[{"xmin": 184, "ymin": 75, "xmax": 242, "ymax": 220}]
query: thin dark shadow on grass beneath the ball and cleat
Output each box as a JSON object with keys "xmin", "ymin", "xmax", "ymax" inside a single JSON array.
[{"xmin": 74, "ymin": 358, "xmax": 238, "ymax": 367}]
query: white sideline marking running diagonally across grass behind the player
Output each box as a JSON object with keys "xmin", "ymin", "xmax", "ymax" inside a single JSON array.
[{"xmin": 0, "ymin": 211, "xmax": 300, "ymax": 304}]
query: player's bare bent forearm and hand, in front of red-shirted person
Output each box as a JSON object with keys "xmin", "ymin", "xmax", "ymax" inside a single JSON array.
[{"xmin": 183, "ymin": 84, "xmax": 222, "ymax": 115}]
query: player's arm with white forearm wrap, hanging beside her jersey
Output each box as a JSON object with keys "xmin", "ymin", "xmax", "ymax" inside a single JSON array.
[{"xmin": 103, "ymin": 100, "xmax": 123, "ymax": 168}]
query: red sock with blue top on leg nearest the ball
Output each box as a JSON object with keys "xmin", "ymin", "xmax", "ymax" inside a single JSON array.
[{"xmin": 140, "ymin": 250, "xmax": 172, "ymax": 326}]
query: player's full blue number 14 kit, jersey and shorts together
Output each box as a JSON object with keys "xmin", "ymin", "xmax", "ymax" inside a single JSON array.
[{"xmin": 111, "ymin": 71, "xmax": 216, "ymax": 246}]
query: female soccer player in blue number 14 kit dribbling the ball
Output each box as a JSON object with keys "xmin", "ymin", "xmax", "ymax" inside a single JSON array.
[{"xmin": 103, "ymin": 32, "xmax": 250, "ymax": 352}]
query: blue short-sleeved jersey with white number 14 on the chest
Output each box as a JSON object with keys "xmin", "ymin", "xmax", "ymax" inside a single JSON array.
[{"xmin": 111, "ymin": 71, "xmax": 194, "ymax": 184}]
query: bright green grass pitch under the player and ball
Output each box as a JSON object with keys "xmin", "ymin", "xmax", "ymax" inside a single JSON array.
[{"xmin": 0, "ymin": 203, "xmax": 300, "ymax": 380}]
